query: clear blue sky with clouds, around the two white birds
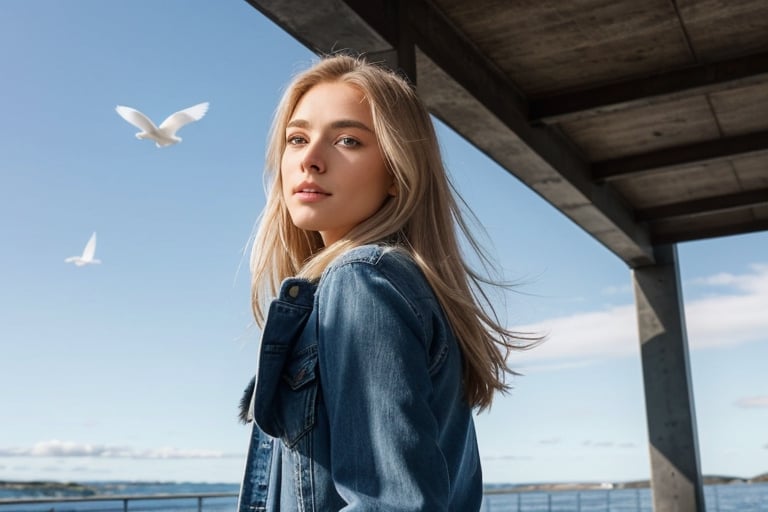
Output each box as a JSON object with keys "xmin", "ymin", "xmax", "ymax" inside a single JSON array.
[{"xmin": 0, "ymin": 0, "xmax": 768, "ymax": 482}]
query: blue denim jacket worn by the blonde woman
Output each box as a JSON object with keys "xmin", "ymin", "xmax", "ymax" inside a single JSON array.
[{"xmin": 238, "ymin": 245, "xmax": 482, "ymax": 512}]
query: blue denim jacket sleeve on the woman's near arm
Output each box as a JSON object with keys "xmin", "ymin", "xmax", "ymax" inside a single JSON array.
[{"xmin": 318, "ymin": 262, "xmax": 450, "ymax": 512}]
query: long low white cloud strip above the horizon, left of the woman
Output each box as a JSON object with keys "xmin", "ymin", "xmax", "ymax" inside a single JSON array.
[{"xmin": 0, "ymin": 439, "xmax": 238, "ymax": 459}]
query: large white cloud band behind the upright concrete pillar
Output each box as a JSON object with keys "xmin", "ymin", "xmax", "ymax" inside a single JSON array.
[{"xmin": 514, "ymin": 264, "xmax": 768, "ymax": 366}]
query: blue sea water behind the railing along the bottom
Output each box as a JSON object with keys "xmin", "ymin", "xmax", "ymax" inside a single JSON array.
[{"xmin": 0, "ymin": 482, "xmax": 768, "ymax": 512}]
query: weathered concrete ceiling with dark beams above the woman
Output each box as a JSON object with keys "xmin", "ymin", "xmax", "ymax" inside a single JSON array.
[{"xmin": 247, "ymin": 0, "xmax": 768, "ymax": 268}]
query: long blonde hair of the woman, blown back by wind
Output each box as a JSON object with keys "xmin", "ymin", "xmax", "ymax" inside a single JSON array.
[{"xmin": 251, "ymin": 55, "xmax": 535, "ymax": 410}]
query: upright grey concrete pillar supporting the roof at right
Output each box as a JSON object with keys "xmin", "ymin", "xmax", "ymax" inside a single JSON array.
[{"xmin": 633, "ymin": 245, "xmax": 704, "ymax": 512}]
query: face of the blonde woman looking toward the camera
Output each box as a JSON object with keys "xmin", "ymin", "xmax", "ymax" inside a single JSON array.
[{"xmin": 280, "ymin": 82, "xmax": 395, "ymax": 246}]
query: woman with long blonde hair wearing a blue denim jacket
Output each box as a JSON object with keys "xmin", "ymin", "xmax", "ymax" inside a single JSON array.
[{"xmin": 239, "ymin": 56, "xmax": 536, "ymax": 512}]
